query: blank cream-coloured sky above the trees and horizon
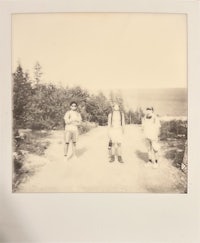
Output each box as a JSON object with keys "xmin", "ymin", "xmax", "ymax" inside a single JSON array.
[{"xmin": 12, "ymin": 13, "xmax": 187, "ymax": 89}]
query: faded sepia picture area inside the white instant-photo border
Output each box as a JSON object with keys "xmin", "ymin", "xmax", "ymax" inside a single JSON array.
[{"xmin": 12, "ymin": 13, "xmax": 188, "ymax": 193}]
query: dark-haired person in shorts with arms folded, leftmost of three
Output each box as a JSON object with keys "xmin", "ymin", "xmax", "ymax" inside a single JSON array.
[{"xmin": 64, "ymin": 101, "xmax": 82, "ymax": 157}]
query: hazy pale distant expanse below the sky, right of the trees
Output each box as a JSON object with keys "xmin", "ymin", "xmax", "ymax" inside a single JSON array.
[{"xmin": 121, "ymin": 88, "xmax": 187, "ymax": 116}]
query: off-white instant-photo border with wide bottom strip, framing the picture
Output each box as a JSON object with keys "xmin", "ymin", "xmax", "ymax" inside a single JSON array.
[{"xmin": 0, "ymin": 0, "xmax": 200, "ymax": 243}]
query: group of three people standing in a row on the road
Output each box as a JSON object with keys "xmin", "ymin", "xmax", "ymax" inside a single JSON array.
[{"xmin": 64, "ymin": 101, "xmax": 160, "ymax": 167}]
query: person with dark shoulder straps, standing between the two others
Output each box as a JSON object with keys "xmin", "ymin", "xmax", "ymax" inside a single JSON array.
[{"xmin": 108, "ymin": 104, "xmax": 125, "ymax": 163}]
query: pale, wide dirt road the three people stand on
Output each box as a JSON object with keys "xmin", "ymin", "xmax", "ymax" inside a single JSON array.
[{"xmin": 18, "ymin": 125, "xmax": 185, "ymax": 193}]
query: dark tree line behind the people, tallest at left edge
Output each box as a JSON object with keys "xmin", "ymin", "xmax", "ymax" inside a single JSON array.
[{"xmin": 12, "ymin": 63, "xmax": 143, "ymax": 129}]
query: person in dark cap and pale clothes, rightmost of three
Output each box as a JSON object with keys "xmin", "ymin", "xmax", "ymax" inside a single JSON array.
[{"xmin": 142, "ymin": 107, "xmax": 160, "ymax": 167}]
